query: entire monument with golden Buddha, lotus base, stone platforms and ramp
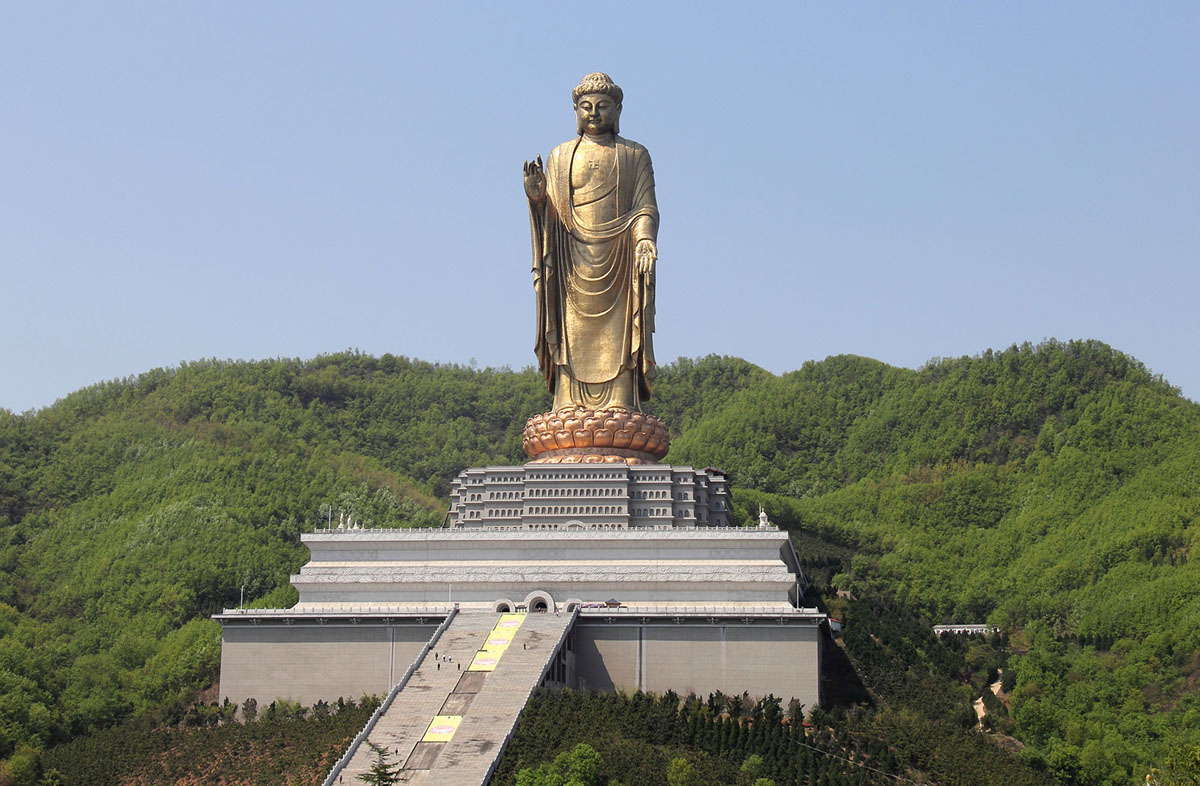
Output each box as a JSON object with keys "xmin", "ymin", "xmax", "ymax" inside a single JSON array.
[{"xmin": 216, "ymin": 73, "xmax": 826, "ymax": 785}]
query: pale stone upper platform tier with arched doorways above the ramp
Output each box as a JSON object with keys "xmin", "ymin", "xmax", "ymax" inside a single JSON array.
[{"xmin": 292, "ymin": 527, "xmax": 800, "ymax": 613}]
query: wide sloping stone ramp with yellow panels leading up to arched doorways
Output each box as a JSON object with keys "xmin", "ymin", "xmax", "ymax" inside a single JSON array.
[{"xmin": 326, "ymin": 611, "xmax": 578, "ymax": 786}]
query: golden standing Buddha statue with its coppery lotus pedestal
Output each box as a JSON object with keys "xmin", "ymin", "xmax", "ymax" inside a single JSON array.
[{"xmin": 524, "ymin": 73, "xmax": 667, "ymax": 463}]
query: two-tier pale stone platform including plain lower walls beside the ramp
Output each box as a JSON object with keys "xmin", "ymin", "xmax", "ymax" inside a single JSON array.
[{"xmin": 216, "ymin": 499, "xmax": 824, "ymax": 739}]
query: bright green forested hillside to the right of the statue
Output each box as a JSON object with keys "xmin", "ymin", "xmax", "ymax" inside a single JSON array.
[{"xmin": 671, "ymin": 342, "xmax": 1200, "ymax": 782}]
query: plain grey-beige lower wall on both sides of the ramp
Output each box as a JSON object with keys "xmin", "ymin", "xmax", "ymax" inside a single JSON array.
[{"xmin": 221, "ymin": 618, "xmax": 821, "ymax": 709}]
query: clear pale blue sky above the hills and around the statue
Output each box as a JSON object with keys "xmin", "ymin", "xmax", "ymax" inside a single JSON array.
[{"xmin": 0, "ymin": 1, "xmax": 1200, "ymax": 412}]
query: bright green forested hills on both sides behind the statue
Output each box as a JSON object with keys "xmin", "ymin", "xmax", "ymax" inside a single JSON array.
[{"xmin": 0, "ymin": 342, "xmax": 1200, "ymax": 784}]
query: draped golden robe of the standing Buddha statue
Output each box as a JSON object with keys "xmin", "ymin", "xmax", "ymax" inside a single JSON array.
[{"xmin": 529, "ymin": 136, "xmax": 659, "ymax": 410}]
